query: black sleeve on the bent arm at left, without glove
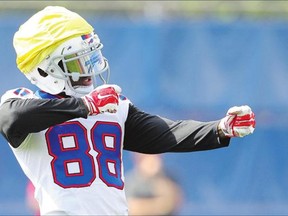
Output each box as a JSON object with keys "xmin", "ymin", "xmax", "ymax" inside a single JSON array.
[{"xmin": 0, "ymin": 96, "xmax": 88, "ymax": 148}]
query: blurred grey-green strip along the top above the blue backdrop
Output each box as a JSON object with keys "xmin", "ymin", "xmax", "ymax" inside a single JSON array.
[{"xmin": 0, "ymin": 0, "xmax": 288, "ymax": 19}]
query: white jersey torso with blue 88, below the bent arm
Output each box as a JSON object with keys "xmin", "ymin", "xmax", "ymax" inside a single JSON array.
[{"xmin": 6, "ymin": 87, "xmax": 130, "ymax": 215}]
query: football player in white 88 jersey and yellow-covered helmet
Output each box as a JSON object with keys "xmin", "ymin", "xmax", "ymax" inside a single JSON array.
[{"xmin": 0, "ymin": 6, "xmax": 255, "ymax": 215}]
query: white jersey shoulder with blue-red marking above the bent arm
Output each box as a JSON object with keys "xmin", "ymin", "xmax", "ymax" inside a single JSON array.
[{"xmin": 0, "ymin": 87, "xmax": 36, "ymax": 104}]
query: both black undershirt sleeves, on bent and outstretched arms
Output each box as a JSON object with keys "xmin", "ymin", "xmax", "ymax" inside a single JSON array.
[{"xmin": 0, "ymin": 97, "xmax": 230, "ymax": 154}]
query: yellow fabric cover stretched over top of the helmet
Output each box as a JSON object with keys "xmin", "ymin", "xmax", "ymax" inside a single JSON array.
[{"xmin": 13, "ymin": 6, "xmax": 94, "ymax": 74}]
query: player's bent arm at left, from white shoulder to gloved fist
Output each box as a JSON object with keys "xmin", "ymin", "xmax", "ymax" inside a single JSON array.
[{"xmin": 0, "ymin": 85, "xmax": 121, "ymax": 148}]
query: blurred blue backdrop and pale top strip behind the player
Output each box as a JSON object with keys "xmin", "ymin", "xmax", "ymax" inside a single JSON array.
[{"xmin": 0, "ymin": 1, "xmax": 288, "ymax": 215}]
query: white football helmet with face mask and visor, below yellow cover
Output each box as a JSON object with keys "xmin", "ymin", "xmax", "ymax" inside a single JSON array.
[{"xmin": 25, "ymin": 33, "xmax": 110, "ymax": 97}]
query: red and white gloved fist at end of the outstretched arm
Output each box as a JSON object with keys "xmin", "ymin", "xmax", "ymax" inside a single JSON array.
[{"xmin": 218, "ymin": 105, "xmax": 256, "ymax": 137}]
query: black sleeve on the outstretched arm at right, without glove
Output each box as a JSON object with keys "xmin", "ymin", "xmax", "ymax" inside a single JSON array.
[{"xmin": 124, "ymin": 105, "xmax": 230, "ymax": 154}]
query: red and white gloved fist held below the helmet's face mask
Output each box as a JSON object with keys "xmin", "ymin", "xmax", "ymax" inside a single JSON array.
[{"xmin": 82, "ymin": 84, "xmax": 121, "ymax": 115}]
